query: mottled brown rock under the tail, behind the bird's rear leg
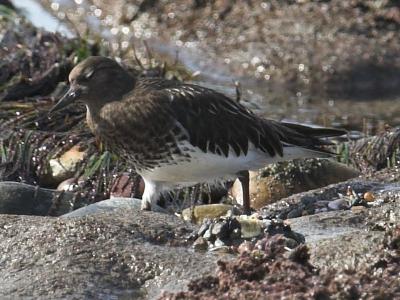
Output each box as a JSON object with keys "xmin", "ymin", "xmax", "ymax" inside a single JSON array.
[{"xmin": 230, "ymin": 159, "xmax": 359, "ymax": 210}]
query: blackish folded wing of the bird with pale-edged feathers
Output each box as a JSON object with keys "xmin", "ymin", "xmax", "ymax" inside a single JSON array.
[{"xmin": 157, "ymin": 83, "xmax": 283, "ymax": 156}]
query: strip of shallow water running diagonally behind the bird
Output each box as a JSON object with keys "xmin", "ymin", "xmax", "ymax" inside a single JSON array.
[{"xmin": 14, "ymin": 0, "xmax": 400, "ymax": 137}]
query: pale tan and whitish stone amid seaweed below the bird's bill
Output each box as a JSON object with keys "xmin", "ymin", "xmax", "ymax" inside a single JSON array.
[{"xmin": 46, "ymin": 146, "xmax": 86, "ymax": 184}]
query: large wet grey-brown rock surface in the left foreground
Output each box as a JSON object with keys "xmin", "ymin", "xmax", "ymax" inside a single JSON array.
[{"xmin": 0, "ymin": 208, "xmax": 223, "ymax": 299}]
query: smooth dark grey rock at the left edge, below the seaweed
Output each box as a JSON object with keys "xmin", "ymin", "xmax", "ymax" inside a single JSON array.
[{"xmin": 0, "ymin": 181, "xmax": 74, "ymax": 216}]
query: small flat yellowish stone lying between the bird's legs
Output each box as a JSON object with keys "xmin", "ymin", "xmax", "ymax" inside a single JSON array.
[{"xmin": 182, "ymin": 204, "xmax": 234, "ymax": 224}]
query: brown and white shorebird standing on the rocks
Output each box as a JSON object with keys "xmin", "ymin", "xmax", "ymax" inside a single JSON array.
[{"xmin": 49, "ymin": 56, "xmax": 346, "ymax": 214}]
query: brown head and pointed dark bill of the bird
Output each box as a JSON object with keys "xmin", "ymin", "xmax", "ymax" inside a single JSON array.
[{"xmin": 49, "ymin": 56, "xmax": 135, "ymax": 114}]
